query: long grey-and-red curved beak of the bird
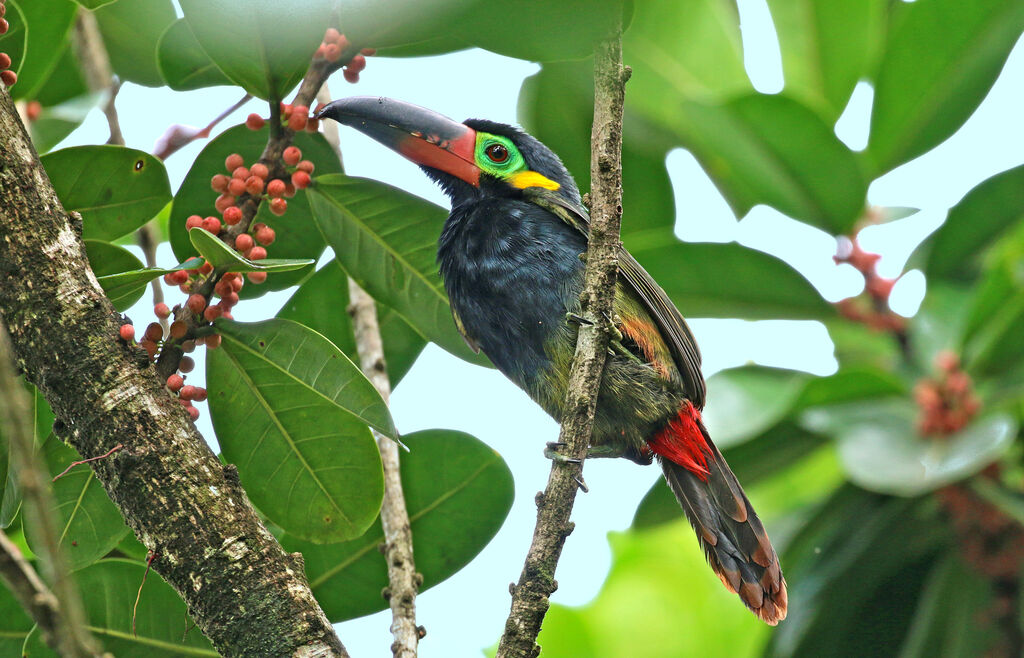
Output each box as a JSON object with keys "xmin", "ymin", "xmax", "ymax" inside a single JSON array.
[{"xmin": 316, "ymin": 96, "xmax": 480, "ymax": 185}]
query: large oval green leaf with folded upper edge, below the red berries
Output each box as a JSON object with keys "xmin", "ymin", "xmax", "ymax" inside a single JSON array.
[{"xmin": 207, "ymin": 319, "xmax": 387, "ymax": 542}]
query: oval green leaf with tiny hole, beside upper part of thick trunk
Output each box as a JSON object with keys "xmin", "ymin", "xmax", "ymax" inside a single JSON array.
[{"xmin": 40, "ymin": 145, "xmax": 171, "ymax": 240}]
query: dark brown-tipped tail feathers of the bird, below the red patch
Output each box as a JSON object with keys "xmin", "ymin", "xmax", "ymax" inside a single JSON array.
[{"xmin": 660, "ymin": 425, "xmax": 787, "ymax": 626}]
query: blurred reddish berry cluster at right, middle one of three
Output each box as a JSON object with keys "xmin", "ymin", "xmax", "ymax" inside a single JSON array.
[{"xmin": 913, "ymin": 351, "xmax": 981, "ymax": 436}]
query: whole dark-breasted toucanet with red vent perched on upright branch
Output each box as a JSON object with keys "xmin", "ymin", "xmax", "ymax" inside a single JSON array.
[{"xmin": 317, "ymin": 96, "xmax": 787, "ymax": 625}]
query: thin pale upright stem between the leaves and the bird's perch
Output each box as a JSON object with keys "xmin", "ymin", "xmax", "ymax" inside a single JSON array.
[{"xmin": 348, "ymin": 279, "xmax": 423, "ymax": 658}]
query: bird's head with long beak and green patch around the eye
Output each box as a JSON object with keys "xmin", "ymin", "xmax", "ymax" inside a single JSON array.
[{"xmin": 317, "ymin": 96, "xmax": 580, "ymax": 206}]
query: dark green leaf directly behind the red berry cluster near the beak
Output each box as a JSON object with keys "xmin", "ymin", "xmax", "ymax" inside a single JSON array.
[{"xmin": 169, "ymin": 126, "xmax": 341, "ymax": 299}]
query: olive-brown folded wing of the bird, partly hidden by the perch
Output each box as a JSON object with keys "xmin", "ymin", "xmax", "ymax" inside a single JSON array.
[{"xmin": 527, "ymin": 188, "xmax": 707, "ymax": 409}]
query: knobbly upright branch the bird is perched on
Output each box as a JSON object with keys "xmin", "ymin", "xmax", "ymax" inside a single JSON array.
[{"xmin": 498, "ymin": 27, "xmax": 630, "ymax": 658}]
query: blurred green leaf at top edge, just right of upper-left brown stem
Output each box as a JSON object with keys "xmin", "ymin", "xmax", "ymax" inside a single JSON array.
[{"xmin": 94, "ymin": 0, "xmax": 176, "ymax": 87}]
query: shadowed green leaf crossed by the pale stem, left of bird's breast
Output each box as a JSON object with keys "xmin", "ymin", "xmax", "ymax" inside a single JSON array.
[{"xmin": 278, "ymin": 260, "xmax": 427, "ymax": 389}]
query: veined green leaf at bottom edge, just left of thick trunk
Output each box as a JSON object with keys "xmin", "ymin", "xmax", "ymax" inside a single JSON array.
[{"xmin": 25, "ymin": 559, "xmax": 218, "ymax": 658}]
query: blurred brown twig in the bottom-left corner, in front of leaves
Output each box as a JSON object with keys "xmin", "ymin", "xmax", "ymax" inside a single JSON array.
[{"xmin": 0, "ymin": 322, "xmax": 101, "ymax": 657}]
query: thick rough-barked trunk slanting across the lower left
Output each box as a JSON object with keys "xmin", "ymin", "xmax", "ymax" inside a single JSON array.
[{"xmin": 0, "ymin": 86, "xmax": 347, "ymax": 656}]
